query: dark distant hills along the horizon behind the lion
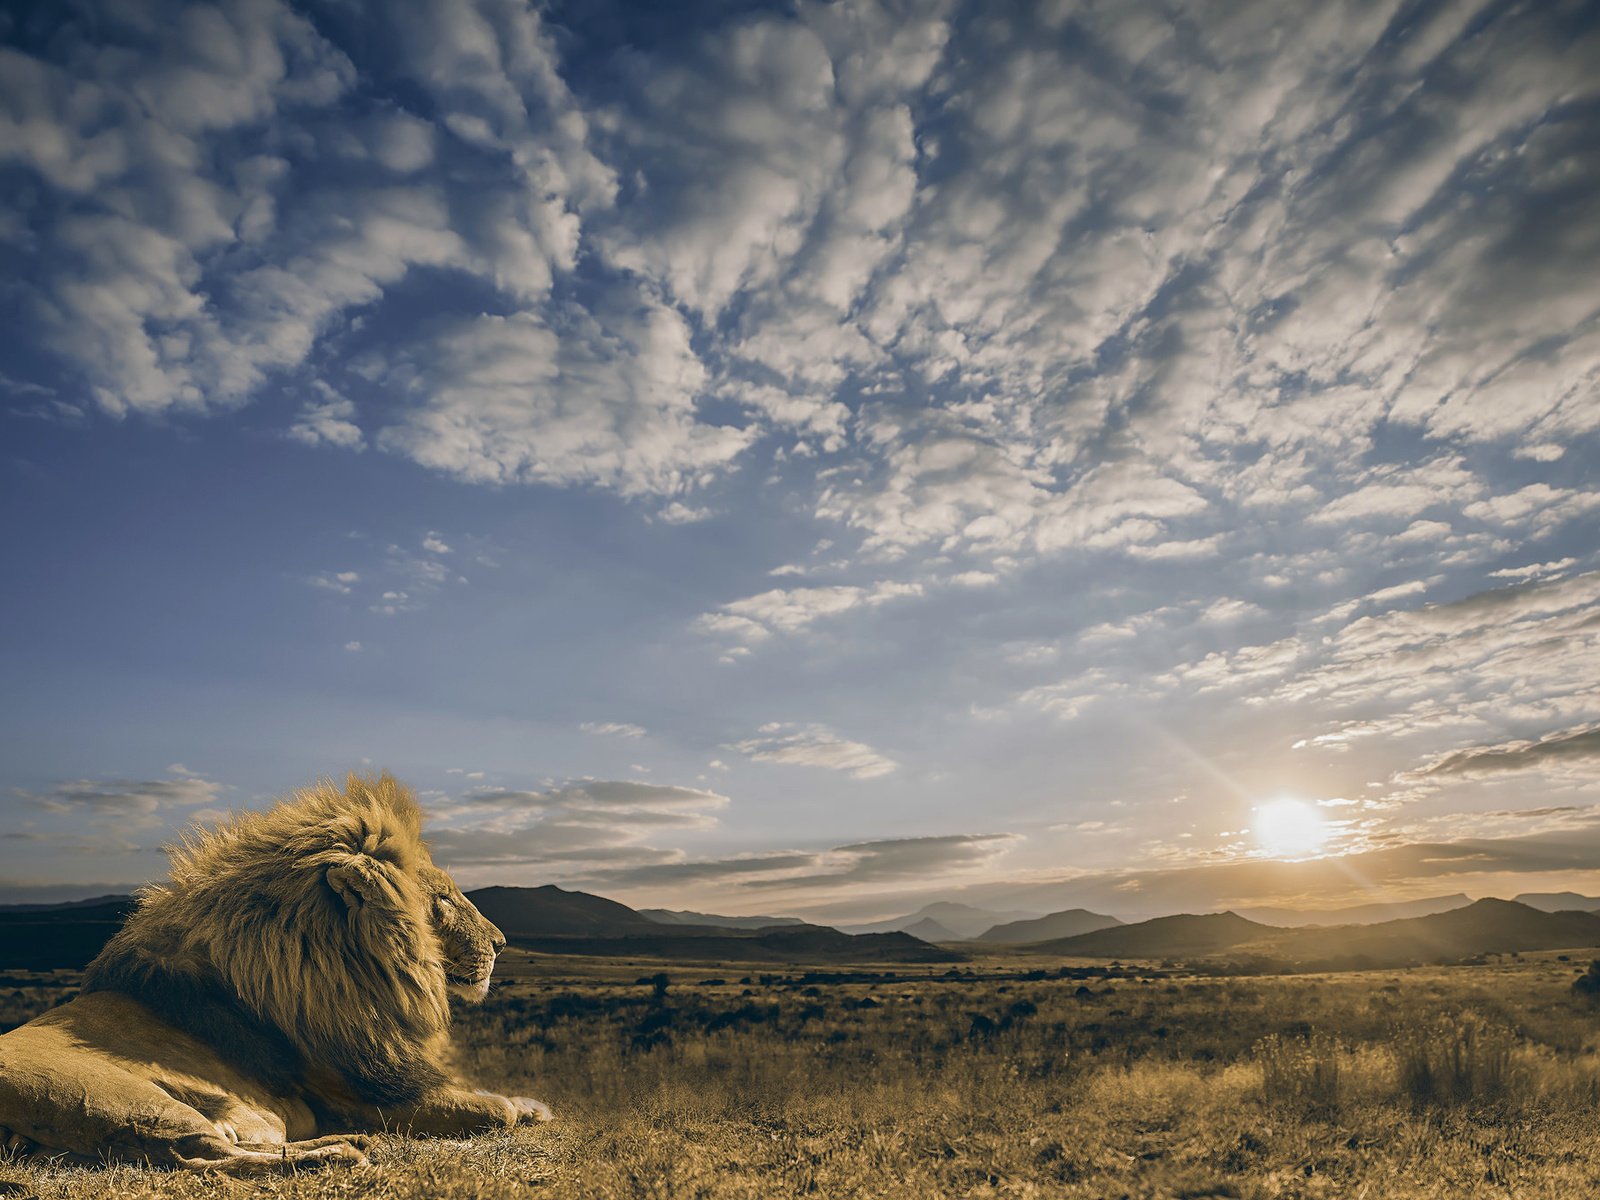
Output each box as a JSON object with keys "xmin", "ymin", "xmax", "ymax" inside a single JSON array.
[{"xmin": 9, "ymin": 885, "xmax": 1600, "ymax": 970}]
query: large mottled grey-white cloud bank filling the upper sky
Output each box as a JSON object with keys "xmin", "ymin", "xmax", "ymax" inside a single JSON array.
[{"xmin": 0, "ymin": 0, "xmax": 1600, "ymax": 544}]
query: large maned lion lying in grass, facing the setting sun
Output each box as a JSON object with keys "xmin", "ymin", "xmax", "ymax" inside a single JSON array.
[{"xmin": 0, "ymin": 773, "xmax": 550, "ymax": 1174}]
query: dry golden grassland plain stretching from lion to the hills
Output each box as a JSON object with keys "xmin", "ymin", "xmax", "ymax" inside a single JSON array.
[{"xmin": 0, "ymin": 950, "xmax": 1600, "ymax": 1200}]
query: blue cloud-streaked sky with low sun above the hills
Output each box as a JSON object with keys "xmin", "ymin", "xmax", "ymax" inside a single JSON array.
[{"xmin": 0, "ymin": 0, "xmax": 1600, "ymax": 920}]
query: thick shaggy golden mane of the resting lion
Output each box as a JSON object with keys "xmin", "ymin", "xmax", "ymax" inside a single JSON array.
[{"xmin": 83, "ymin": 774, "xmax": 450, "ymax": 1106}]
